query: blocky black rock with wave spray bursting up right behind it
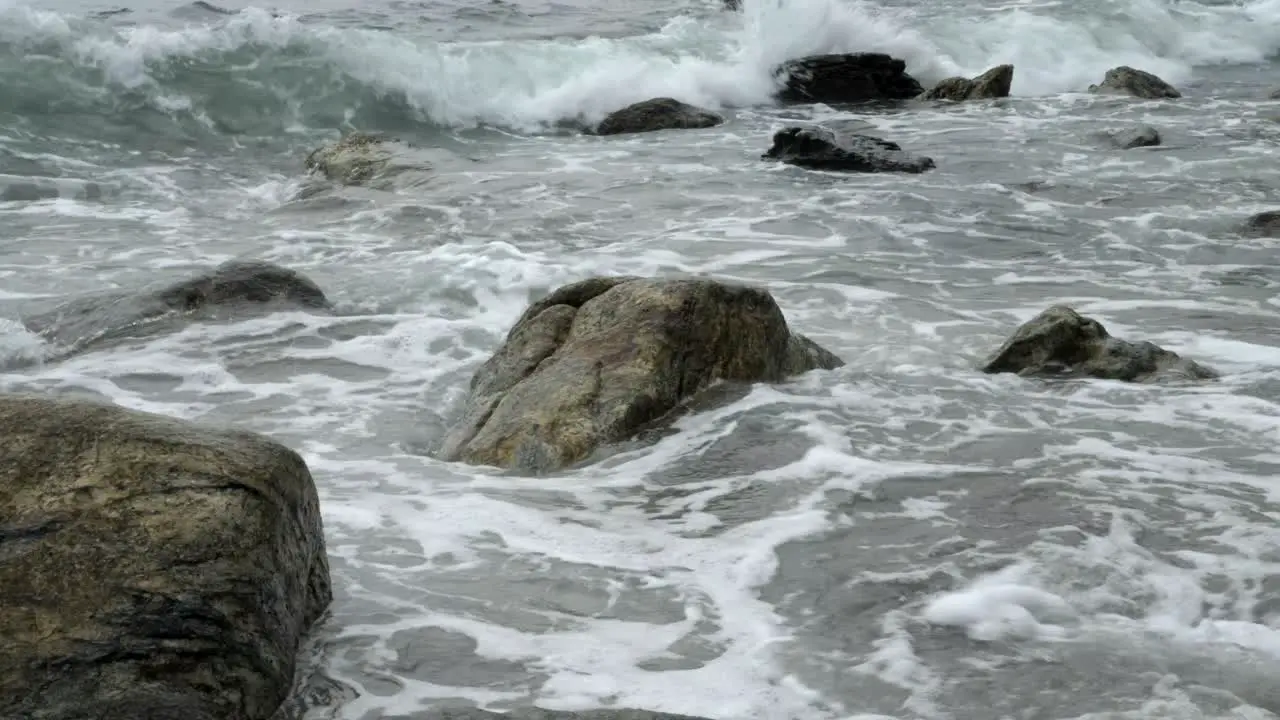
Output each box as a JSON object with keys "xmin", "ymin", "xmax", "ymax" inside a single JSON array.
[{"xmin": 773, "ymin": 53, "xmax": 924, "ymax": 104}]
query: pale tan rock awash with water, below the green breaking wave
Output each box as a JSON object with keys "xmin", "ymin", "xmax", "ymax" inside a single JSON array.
[{"xmin": 306, "ymin": 132, "xmax": 449, "ymax": 191}]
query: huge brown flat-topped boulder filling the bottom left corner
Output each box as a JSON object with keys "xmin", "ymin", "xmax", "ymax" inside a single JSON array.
[{"xmin": 0, "ymin": 396, "xmax": 330, "ymax": 720}]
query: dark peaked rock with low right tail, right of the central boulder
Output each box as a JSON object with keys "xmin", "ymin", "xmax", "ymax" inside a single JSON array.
[{"xmin": 982, "ymin": 305, "xmax": 1217, "ymax": 382}]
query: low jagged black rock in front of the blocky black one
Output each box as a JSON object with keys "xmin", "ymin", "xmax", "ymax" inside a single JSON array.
[{"xmin": 762, "ymin": 127, "xmax": 934, "ymax": 173}]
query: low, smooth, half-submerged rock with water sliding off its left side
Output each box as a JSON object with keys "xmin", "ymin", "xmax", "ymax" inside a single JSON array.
[{"xmin": 23, "ymin": 260, "xmax": 332, "ymax": 352}]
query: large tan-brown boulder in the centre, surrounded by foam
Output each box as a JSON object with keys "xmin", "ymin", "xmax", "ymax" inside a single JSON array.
[{"xmin": 440, "ymin": 277, "xmax": 842, "ymax": 474}]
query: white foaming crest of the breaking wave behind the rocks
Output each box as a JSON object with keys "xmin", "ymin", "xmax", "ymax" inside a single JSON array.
[{"xmin": 0, "ymin": 0, "xmax": 1280, "ymax": 129}]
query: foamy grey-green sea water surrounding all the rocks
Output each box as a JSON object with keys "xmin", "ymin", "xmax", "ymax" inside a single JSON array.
[{"xmin": 0, "ymin": 0, "xmax": 1280, "ymax": 720}]
